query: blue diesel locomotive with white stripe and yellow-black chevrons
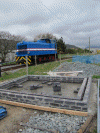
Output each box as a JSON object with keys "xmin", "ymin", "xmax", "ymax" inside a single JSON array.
[{"xmin": 16, "ymin": 39, "xmax": 58, "ymax": 65}]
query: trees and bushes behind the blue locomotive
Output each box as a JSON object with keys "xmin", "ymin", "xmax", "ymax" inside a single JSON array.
[{"xmin": 0, "ymin": 31, "xmax": 89, "ymax": 62}]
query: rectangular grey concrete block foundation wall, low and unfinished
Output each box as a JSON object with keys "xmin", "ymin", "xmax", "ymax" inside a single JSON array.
[{"xmin": 0, "ymin": 75, "xmax": 92, "ymax": 112}]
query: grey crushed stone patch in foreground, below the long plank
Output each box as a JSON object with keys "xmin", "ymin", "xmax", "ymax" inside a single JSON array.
[{"xmin": 18, "ymin": 112, "xmax": 87, "ymax": 133}]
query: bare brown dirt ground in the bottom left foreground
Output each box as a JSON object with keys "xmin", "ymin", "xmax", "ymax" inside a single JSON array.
[{"xmin": 0, "ymin": 103, "xmax": 35, "ymax": 133}]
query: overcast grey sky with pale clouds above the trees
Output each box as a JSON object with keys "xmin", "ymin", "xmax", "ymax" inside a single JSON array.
[{"xmin": 0, "ymin": 0, "xmax": 100, "ymax": 48}]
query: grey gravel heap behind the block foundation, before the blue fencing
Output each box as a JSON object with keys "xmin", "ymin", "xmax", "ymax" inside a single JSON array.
[{"xmin": 53, "ymin": 62, "xmax": 100, "ymax": 77}]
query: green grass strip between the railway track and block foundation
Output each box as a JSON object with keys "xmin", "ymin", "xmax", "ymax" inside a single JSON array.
[{"xmin": 0, "ymin": 60, "xmax": 66, "ymax": 81}]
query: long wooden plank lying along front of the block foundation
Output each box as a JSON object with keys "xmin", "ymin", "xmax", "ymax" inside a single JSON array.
[{"xmin": 0, "ymin": 99, "xmax": 88, "ymax": 116}]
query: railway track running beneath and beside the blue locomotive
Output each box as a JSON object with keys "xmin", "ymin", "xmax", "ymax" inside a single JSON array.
[{"xmin": 1, "ymin": 57, "xmax": 72, "ymax": 72}]
